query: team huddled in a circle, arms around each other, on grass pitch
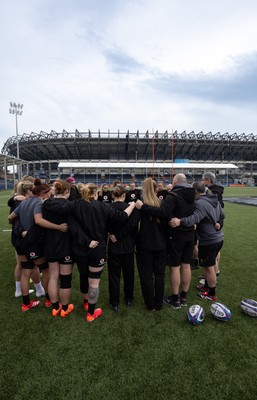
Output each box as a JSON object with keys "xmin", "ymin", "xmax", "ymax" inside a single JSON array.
[{"xmin": 8, "ymin": 173, "xmax": 224, "ymax": 322}]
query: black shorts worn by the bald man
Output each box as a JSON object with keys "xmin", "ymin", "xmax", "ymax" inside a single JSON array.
[{"xmin": 167, "ymin": 238, "xmax": 195, "ymax": 267}]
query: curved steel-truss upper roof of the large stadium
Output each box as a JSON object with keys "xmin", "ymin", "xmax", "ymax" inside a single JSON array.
[{"xmin": 2, "ymin": 130, "xmax": 257, "ymax": 163}]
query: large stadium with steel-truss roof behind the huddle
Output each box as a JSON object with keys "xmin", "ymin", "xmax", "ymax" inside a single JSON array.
[{"xmin": 1, "ymin": 130, "xmax": 257, "ymax": 188}]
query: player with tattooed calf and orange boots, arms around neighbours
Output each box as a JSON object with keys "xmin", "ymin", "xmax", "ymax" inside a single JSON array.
[{"xmin": 42, "ymin": 184, "xmax": 135, "ymax": 322}]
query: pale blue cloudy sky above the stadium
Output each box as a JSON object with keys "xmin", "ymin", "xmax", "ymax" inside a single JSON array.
[{"xmin": 0, "ymin": 0, "xmax": 257, "ymax": 150}]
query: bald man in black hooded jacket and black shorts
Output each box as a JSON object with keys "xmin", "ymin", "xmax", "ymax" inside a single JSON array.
[{"xmin": 136, "ymin": 173, "xmax": 195, "ymax": 309}]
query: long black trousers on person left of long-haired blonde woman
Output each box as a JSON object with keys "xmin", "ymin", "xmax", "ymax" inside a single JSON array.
[{"xmin": 108, "ymin": 251, "xmax": 134, "ymax": 306}]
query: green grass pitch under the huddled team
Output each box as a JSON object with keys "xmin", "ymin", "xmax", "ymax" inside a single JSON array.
[{"xmin": 0, "ymin": 190, "xmax": 257, "ymax": 400}]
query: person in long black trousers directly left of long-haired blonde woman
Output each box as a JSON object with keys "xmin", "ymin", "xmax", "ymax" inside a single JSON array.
[{"xmin": 107, "ymin": 185, "xmax": 140, "ymax": 311}]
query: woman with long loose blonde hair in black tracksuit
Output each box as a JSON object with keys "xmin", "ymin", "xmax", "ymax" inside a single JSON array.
[{"xmin": 136, "ymin": 178, "xmax": 166, "ymax": 311}]
